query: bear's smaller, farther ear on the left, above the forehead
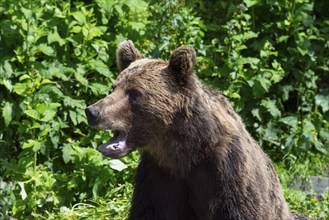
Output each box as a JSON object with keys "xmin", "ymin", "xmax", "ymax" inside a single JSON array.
[{"xmin": 117, "ymin": 40, "xmax": 144, "ymax": 71}]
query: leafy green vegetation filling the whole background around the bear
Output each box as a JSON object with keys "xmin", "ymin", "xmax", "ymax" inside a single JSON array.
[{"xmin": 0, "ymin": 0, "xmax": 329, "ymax": 219}]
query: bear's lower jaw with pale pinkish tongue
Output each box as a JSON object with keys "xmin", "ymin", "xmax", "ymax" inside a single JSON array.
[{"xmin": 98, "ymin": 134, "xmax": 127, "ymax": 157}]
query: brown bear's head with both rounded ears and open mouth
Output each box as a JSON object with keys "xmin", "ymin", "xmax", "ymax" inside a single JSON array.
[{"xmin": 86, "ymin": 41, "xmax": 197, "ymax": 158}]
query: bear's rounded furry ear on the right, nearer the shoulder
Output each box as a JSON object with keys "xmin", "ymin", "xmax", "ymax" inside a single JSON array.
[{"xmin": 168, "ymin": 46, "xmax": 196, "ymax": 85}]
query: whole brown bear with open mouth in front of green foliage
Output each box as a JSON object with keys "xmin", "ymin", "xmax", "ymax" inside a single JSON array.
[{"xmin": 86, "ymin": 41, "xmax": 291, "ymax": 220}]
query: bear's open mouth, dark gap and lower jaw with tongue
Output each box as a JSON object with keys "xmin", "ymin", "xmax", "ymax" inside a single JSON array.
[{"xmin": 98, "ymin": 130, "xmax": 133, "ymax": 158}]
